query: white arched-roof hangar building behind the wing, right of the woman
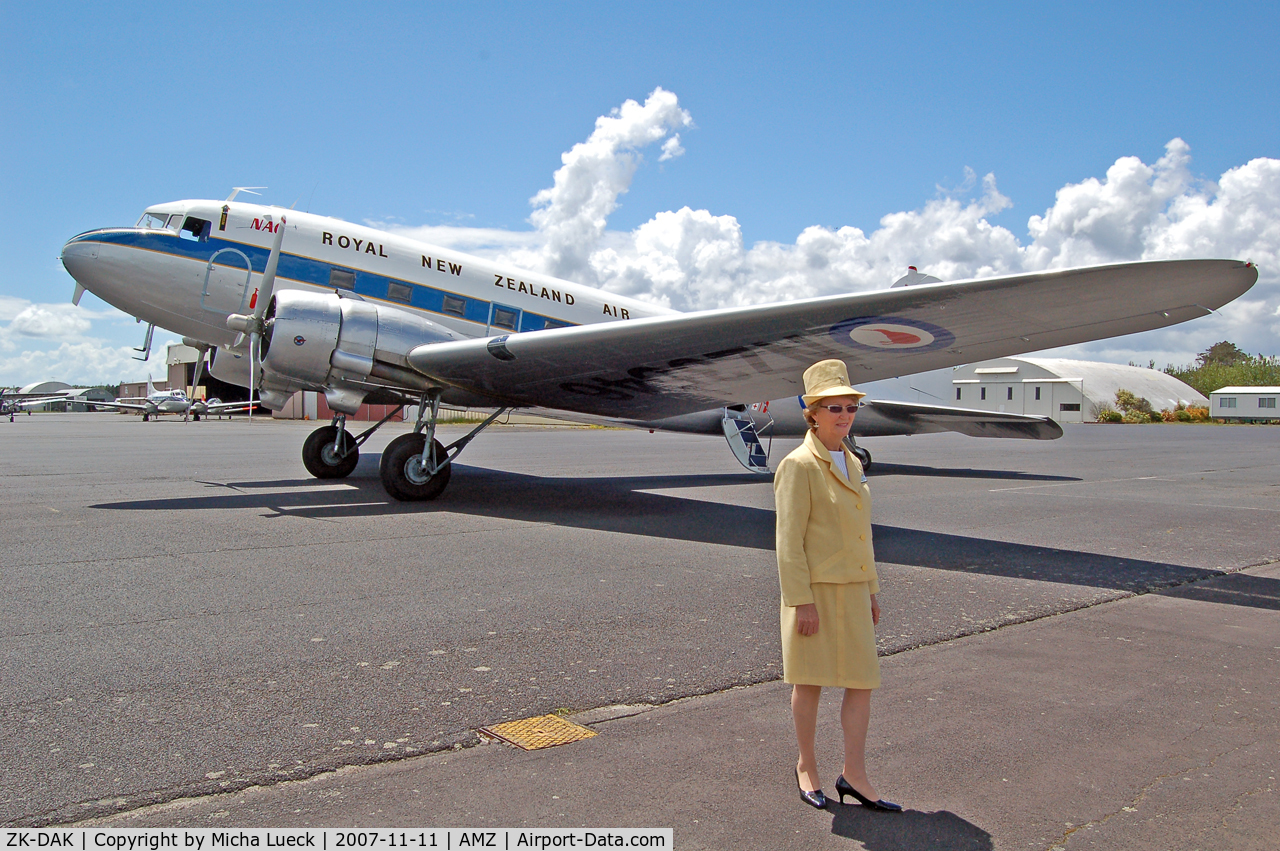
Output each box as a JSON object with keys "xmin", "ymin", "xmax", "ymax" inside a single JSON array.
[{"xmin": 859, "ymin": 357, "xmax": 1208, "ymax": 422}]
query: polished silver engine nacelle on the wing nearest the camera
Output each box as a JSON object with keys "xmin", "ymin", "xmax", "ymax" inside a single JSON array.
[{"xmin": 262, "ymin": 289, "xmax": 460, "ymax": 413}]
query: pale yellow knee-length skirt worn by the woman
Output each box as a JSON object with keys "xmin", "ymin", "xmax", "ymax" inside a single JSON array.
[{"xmin": 782, "ymin": 582, "xmax": 879, "ymax": 688}]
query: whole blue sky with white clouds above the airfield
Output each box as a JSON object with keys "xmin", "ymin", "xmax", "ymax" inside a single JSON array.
[{"xmin": 0, "ymin": 0, "xmax": 1280, "ymax": 386}]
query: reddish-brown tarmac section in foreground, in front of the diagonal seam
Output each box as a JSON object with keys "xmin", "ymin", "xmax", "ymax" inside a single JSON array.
[{"xmin": 81, "ymin": 563, "xmax": 1280, "ymax": 851}]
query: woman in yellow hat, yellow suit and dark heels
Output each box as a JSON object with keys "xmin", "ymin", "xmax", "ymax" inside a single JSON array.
[{"xmin": 773, "ymin": 360, "xmax": 902, "ymax": 813}]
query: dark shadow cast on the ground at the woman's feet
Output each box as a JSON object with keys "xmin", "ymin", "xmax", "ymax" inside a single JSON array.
[{"xmin": 827, "ymin": 801, "xmax": 995, "ymax": 851}]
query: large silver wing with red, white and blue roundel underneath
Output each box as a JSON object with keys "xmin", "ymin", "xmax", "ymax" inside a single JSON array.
[{"xmin": 407, "ymin": 260, "xmax": 1258, "ymax": 420}]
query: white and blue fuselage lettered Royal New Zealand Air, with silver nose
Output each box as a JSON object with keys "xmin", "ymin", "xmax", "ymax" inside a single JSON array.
[{"xmin": 61, "ymin": 201, "xmax": 672, "ymax": 346}]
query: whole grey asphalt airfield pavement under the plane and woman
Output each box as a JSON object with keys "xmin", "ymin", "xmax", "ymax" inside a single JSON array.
[{"xmin": 0, "ymin": 415, "xmax": 1280, "ymax": 847}]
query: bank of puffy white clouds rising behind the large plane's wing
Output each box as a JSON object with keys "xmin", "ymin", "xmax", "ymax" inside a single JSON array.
[{"xmin": 417, "ymin": 104, "xmax": 1280, "ymax": 365}]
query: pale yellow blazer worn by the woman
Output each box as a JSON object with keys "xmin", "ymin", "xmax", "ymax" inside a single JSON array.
[{"xmin": 773, "ymin": 430, "xmax": 879, "ymax": 607}]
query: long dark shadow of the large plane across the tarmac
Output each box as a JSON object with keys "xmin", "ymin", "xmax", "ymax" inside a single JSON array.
[{"xmin": 92, "ymin": 458, "xmax": 1280, "ymax": 609}]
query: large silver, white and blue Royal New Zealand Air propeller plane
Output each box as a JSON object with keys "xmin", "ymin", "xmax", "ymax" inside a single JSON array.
[{"xmin": 61, "ymin": 189, "xmax": 1258, "ymax": 500}]
